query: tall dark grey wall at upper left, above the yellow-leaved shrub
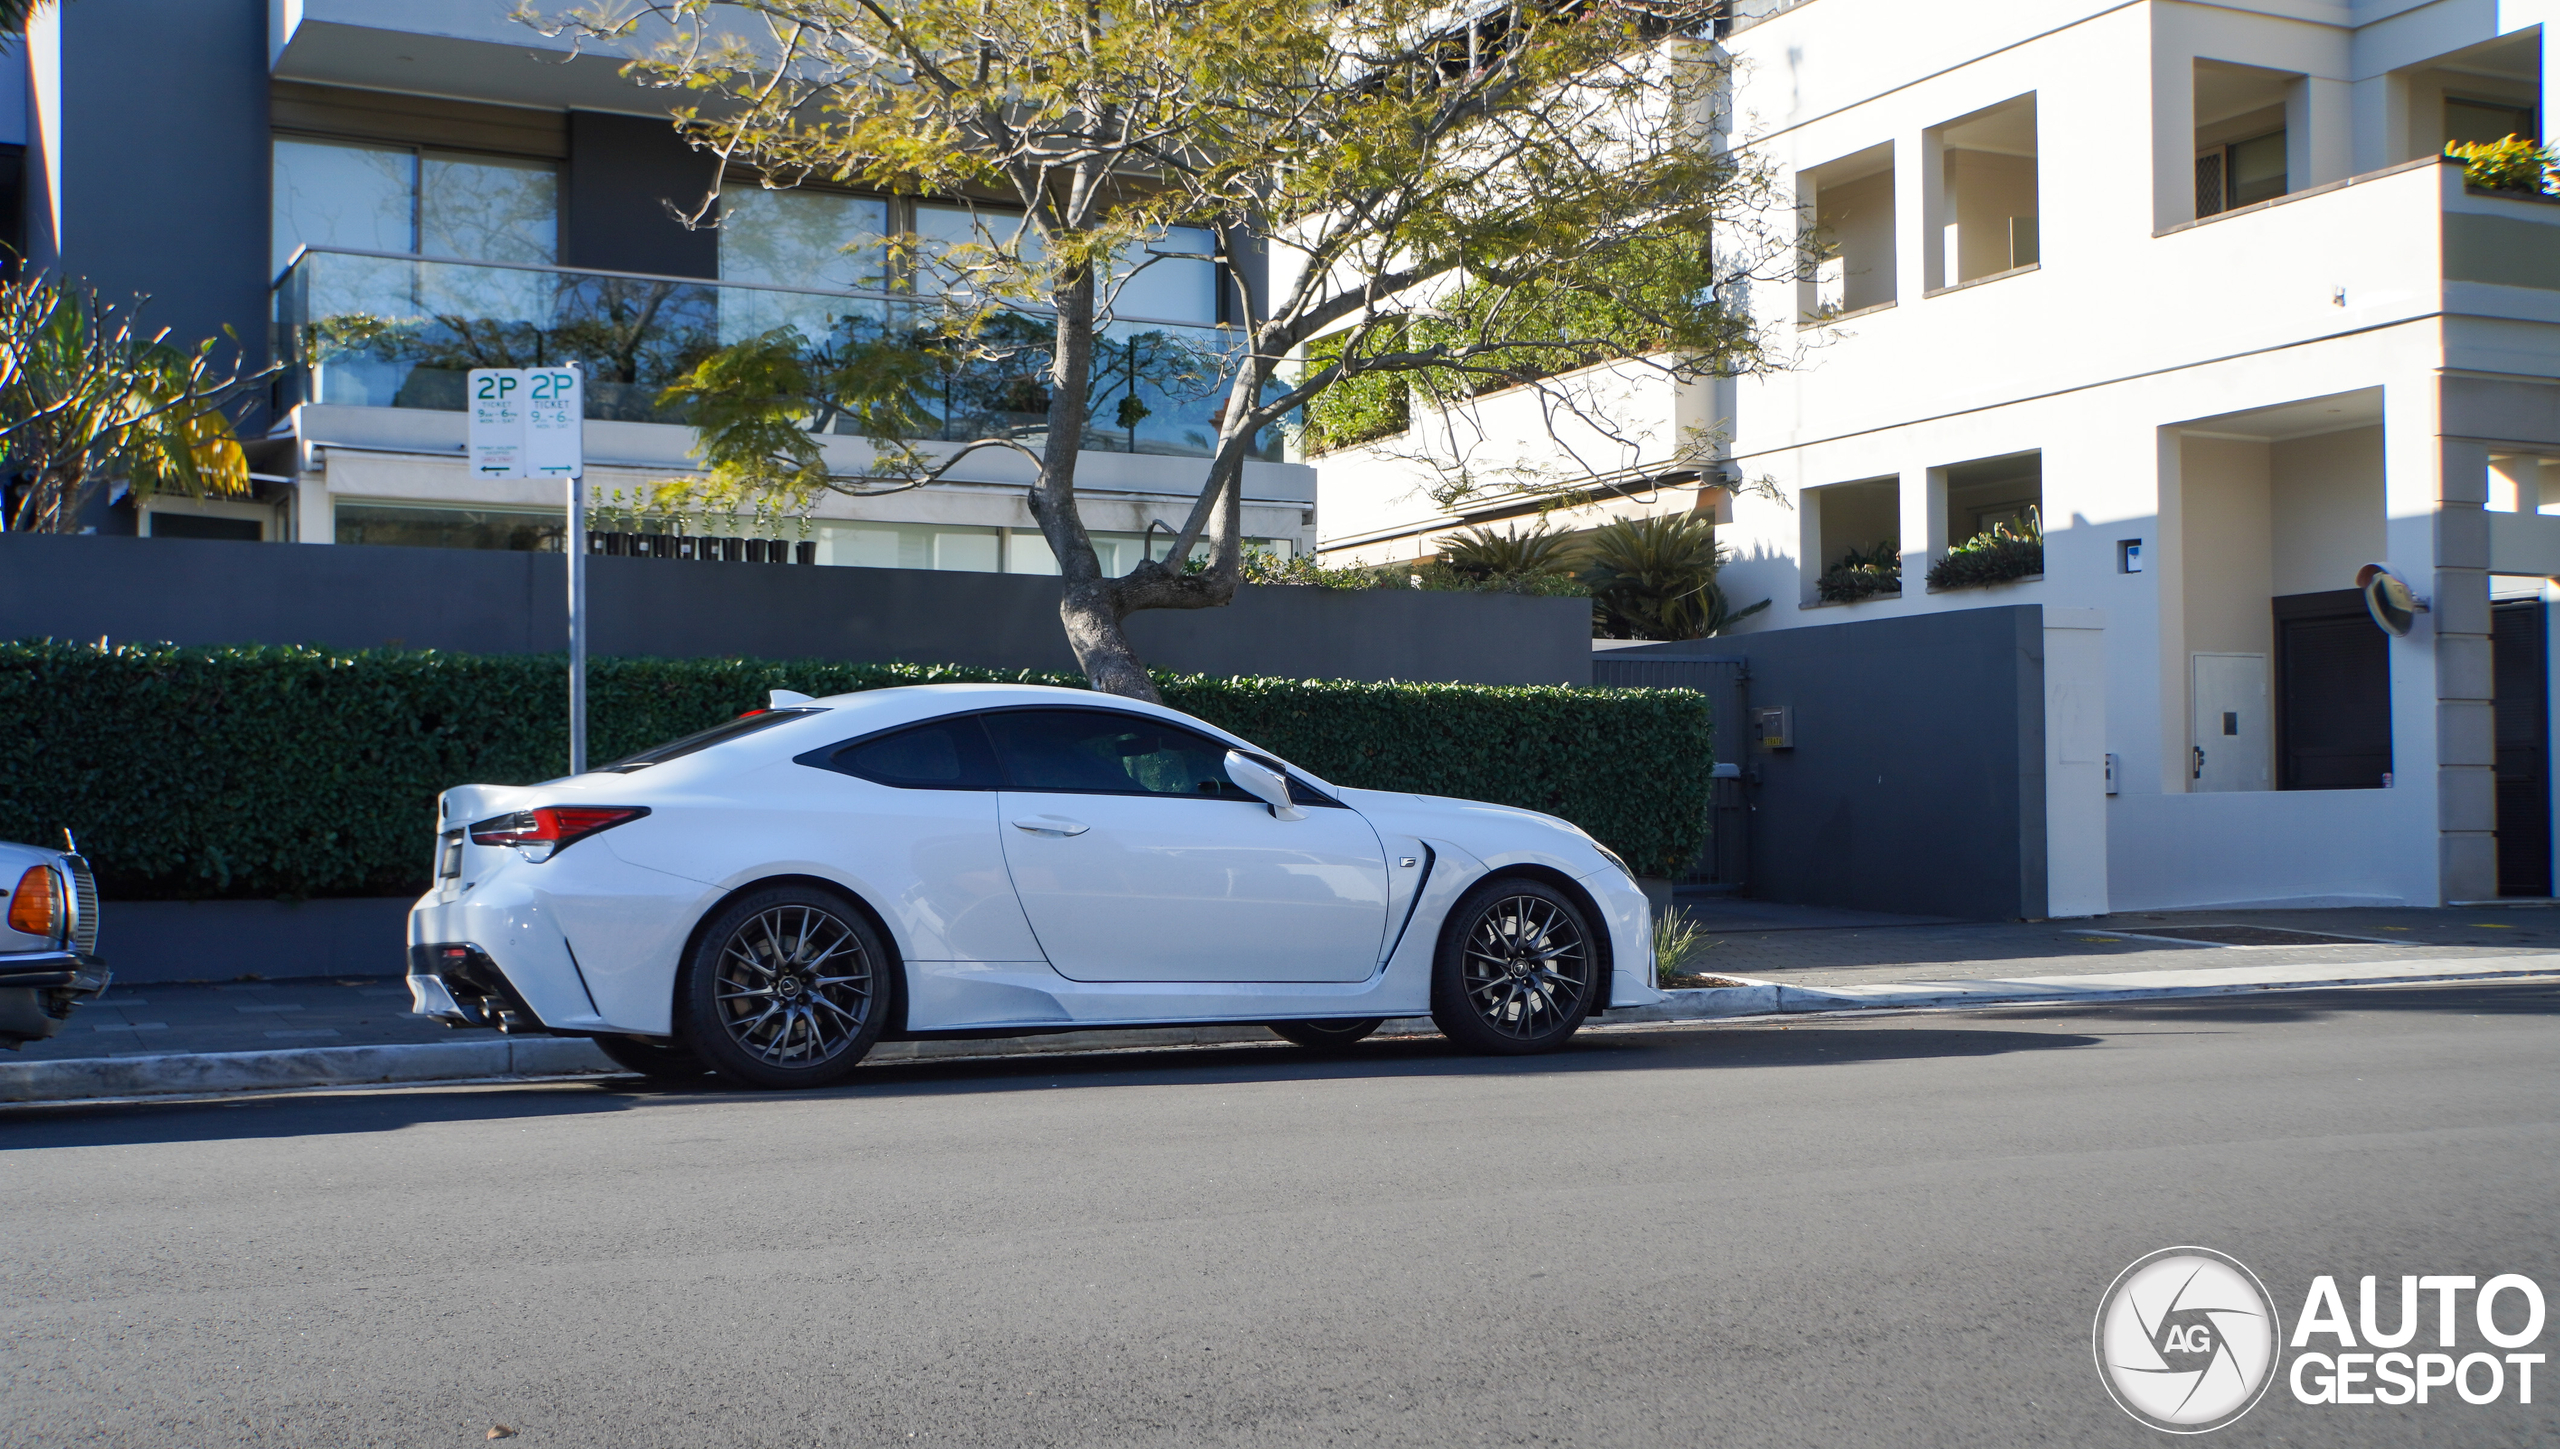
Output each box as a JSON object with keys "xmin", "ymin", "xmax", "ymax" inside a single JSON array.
[{"xmin": 47, "ymin": 0, "xmax": 269, "ymax": 384}]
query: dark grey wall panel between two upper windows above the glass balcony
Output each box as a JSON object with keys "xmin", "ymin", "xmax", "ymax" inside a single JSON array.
[{"xmin": 561, "ymin": 110, "xmax": 719, "ymax": 276}]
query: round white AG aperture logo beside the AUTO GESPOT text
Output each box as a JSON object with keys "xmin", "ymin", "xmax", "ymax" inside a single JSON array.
[{"xmin": 2092, "ymin": 1247, "xmax": 2278, "ymax": 1434}]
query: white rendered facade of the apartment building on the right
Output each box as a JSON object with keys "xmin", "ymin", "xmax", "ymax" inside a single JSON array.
[{"xmin": 1318, "ymin": 0, "xmax": 2560, "ymax": 917}]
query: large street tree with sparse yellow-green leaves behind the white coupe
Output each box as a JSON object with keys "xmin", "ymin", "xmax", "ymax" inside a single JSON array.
[{"xmin": 545, "ymin": 0, "xmax": 1795, "ymax": 699}]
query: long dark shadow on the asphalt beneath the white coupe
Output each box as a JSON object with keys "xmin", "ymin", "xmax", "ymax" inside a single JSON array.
[{"xmin": 0, "ymin": 1019, "xmax": 2102, "ymax": 1149}]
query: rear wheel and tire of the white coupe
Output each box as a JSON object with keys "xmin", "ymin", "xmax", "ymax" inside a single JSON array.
[{"xmin": 676, "ymin": 886, "xmax": 899, "ymax": 1088}]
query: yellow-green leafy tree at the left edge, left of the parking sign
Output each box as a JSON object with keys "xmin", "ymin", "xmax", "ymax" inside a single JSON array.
[{"xmin": 0, "ymin": 276, "xmax": 271, "ymax": 532}]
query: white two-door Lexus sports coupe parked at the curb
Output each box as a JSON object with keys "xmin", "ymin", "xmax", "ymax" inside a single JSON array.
[{"xmin": 410, "ymin": 684, "xmax": 1661, "ymax": 1088}]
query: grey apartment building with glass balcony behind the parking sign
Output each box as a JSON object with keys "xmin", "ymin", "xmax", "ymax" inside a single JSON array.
[{"xmin": 20, "ymin": 0, "xmax": 1316, "ymax": 573}]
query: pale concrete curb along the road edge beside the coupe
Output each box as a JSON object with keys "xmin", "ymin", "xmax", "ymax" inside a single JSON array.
[{"xmin": 0, "ymin": 957, "xmax": 2560, "ymax": 1103}]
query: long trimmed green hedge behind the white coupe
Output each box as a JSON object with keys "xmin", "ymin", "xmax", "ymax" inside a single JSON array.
[{"xmin": 0, "ymin": 643, "xmax": 1710, "ymax": 899}]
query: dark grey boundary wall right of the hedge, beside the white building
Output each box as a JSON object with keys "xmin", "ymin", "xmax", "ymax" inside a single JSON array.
[{"xmin": 1603, "ymin": 604, "xmax": 2045, "ymax": 919}]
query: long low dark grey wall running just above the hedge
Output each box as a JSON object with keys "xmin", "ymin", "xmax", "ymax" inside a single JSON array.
[{"xmin": 0, "ymin": 532, "xmax": 1590, "ymax": 684}]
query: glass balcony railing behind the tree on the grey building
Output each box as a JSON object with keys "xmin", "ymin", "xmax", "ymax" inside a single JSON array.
[{"xmin": 274, "ymin": 248, "xmax": 1280, "ymax": 461}]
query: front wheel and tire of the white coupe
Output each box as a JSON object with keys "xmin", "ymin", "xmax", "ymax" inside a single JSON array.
[{"xmin": 1431, "ymin": 876, "xmax": 1603, "ymax": 1057}]
